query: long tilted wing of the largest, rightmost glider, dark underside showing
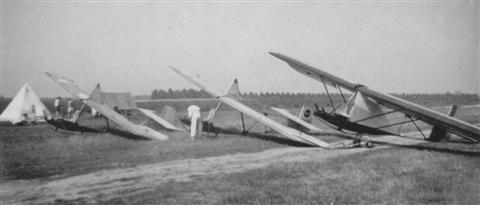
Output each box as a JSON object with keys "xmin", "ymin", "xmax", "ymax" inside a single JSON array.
[{"xmin": 270, "ymin": 52, "xmax": 480, "ymax": 141}]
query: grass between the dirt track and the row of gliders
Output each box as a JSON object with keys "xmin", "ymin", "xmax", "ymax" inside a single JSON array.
[{"xmin": 0, "ymin": 117, "xmax": 293, "ymax": 181}]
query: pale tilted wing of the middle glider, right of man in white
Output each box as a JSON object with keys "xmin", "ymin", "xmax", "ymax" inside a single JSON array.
[{"xmin": 170, "ymin": 66, "xmax": 330, "ymax": 148}]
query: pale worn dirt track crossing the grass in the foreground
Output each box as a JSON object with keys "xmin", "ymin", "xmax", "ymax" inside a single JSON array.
[{"xmin": 0, "ymin": 136, "xmax": 421, "ymax": 204}]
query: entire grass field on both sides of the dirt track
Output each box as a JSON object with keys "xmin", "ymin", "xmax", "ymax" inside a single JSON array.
[{"xmin": 0, "ymin": 98, "xmax": 480, "ymax": 204}]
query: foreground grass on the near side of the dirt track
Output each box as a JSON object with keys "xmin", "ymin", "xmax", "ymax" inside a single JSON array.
[{"xmin": 102, "ymin": 146, "xmax": 480, "ymax": 204}]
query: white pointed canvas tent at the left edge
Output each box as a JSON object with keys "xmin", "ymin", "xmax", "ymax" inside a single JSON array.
[{"xmin": 0, "ymin": 83, "xmax": 51, "ymax": 124}]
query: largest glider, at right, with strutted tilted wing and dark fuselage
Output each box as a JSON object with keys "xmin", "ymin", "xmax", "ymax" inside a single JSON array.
[{"xmin": 270, "ymin": 52, "xmax": 480, "ymax": 142}]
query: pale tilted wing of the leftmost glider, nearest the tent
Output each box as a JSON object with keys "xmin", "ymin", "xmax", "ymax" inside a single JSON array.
[{"xmin": 46, "ymin": 72, "xmax": 168, "ymax": 140}]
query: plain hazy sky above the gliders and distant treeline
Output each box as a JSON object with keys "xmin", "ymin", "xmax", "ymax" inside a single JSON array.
[{"xmin": 0, "ymin": 1, "xmax": 480, "ymax": 97}]
